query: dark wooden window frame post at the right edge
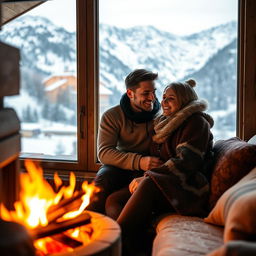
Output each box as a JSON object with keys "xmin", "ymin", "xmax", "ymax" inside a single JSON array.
[{"xmin": 237, "ymin": 0, "xmax": 256, "ymax": 141}]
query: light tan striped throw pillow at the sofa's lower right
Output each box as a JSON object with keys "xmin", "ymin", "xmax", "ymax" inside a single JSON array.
[{"xmin": 204, "ymin": 168, "xmax": 256, "ymax": 242}]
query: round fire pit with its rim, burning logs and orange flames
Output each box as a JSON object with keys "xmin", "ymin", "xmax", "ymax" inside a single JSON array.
[{"xmin": 0, "ymin": 160, "xmax": 121, "ymax": 256}]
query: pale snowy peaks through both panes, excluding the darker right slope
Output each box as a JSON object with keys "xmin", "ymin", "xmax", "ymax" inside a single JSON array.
[{"xmin": 0, "ymin": 16, "xmax": 237, "ymax": 91}]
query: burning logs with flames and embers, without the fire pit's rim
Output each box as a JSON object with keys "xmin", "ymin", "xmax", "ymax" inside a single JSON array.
[{"xmin": 0, "ymin": 160, "xmax": 102, "ymax": 255}]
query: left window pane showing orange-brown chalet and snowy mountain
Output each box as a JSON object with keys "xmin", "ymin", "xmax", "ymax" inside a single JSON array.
[{"xmin": 0, "ymin": 0, "xmax": 77, "ymax": 160}]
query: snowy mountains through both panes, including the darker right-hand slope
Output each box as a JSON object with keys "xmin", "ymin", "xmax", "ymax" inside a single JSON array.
[{"xmin": 0, "ymin": 16, "xmax": 237, "ymax": 138}]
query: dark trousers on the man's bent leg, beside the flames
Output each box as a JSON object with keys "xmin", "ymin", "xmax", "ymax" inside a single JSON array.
[{"xmin": 86, "ymin": 165, "xmax": 144, "ymax": 213}]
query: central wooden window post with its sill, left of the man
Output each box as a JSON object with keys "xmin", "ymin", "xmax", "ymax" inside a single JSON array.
[{"xmin": 20, "ymin": 0, "xmax": 100, "ymax": 179}]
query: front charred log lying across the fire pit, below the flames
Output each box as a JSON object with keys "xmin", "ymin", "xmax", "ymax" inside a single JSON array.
[{"xmin": 31, "ymin": 212, "xmax": 91, "ymax": 239}]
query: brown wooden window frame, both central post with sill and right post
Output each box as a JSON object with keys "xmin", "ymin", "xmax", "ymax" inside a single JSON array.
[{"xmin": 22, "ymin": 0, "xmax": 256, "ymax": 174}]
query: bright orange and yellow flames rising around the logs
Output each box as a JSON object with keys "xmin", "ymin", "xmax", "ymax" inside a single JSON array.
[{"xmin": 0, "ymin": 160, "xmax": 99, "ymax": 253}]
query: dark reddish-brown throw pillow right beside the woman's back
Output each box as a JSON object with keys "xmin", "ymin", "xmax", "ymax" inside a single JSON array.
[{"xmin": 209, "ymin": 137, "xmax": 256, "ymax": 209}]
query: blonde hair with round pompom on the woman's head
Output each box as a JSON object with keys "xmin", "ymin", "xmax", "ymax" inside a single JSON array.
[{"xmin": 164, "ymin": 79, "xmax": 198, "ymax": 108}]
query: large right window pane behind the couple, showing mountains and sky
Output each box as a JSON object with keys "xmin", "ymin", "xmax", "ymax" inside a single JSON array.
[{"xmin": 99, "ymin": 0, "xmax": 238, "ymax": 140}]
